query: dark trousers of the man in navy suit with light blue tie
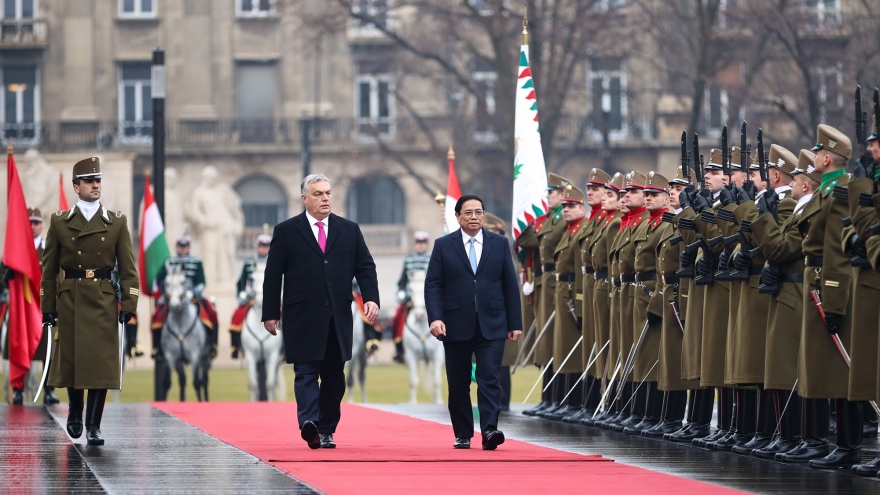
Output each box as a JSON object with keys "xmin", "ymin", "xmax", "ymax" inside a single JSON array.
[{"xmin": 443, "ymin": 322, "xmax": 504, "ymax": 438}]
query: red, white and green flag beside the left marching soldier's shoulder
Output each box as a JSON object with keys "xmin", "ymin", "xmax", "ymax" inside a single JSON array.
[{"xmin": 138, "ymin": 175, "xmax": 171, "ymax": 297}]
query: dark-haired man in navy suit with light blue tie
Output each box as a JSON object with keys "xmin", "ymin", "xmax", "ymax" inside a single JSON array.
[{"xmin": 425, "ymin": 195, "xmax": 522, "ymax": 450}]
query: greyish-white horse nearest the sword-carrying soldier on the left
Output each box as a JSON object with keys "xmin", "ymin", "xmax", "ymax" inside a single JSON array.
[{"xmin": 162, "ymin": 267, "xmax": 211, "ymax": 401}]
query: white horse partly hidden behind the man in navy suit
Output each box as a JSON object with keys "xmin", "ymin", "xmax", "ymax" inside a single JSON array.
[{"xmin": 403, "ymin": 270, "xmax": 446, "ymax": 404}]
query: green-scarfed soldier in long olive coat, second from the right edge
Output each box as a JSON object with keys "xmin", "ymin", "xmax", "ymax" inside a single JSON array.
[{"xmin": 786, "ymin": 124, "xmax": 862, "ymax": 468}]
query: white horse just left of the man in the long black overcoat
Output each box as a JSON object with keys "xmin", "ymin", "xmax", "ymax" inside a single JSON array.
[{"xmin": 241, "ymin": 262, "xmax": 287, "ymax": 402}]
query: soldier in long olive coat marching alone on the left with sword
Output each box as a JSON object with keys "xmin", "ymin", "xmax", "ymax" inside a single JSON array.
[{"xmin": 40, "ymin": 157, "xmax": 138, "ymax": 445}]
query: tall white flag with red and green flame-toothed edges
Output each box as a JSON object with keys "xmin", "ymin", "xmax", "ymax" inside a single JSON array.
[{"xmin": 511, "ymin": 35, "xmax": 547, "ymax": 260}]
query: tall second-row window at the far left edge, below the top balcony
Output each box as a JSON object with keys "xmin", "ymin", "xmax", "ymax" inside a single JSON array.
[{"xmin": 0, "ymin": 65, "xmax": 40, "ymax": 144}]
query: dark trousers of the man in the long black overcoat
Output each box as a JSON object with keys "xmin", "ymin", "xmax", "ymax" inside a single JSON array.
[{"xmin": 293, "ymin": 319, "xmax": 345, "ymax": 434}]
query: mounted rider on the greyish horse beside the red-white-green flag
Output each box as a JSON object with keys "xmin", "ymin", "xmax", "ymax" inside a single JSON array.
[{"xmin": 152, "ymin": 235, "xmax": 220, "ymax": 359}]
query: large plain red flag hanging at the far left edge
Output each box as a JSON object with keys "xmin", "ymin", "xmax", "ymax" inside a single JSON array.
[{"xmin": 3, "ymin": 151, "xmax": 44, "ymax": 388}]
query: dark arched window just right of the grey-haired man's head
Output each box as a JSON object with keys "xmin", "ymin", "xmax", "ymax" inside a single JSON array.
[{"xmin": 347, "ymin": 175, "xmax": 406, "ymax": 225}]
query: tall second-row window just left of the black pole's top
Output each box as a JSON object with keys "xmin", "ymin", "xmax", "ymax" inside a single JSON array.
[{"xmin": 119, "ymin": 62, "xmax": 153, "ymax": 144}]
